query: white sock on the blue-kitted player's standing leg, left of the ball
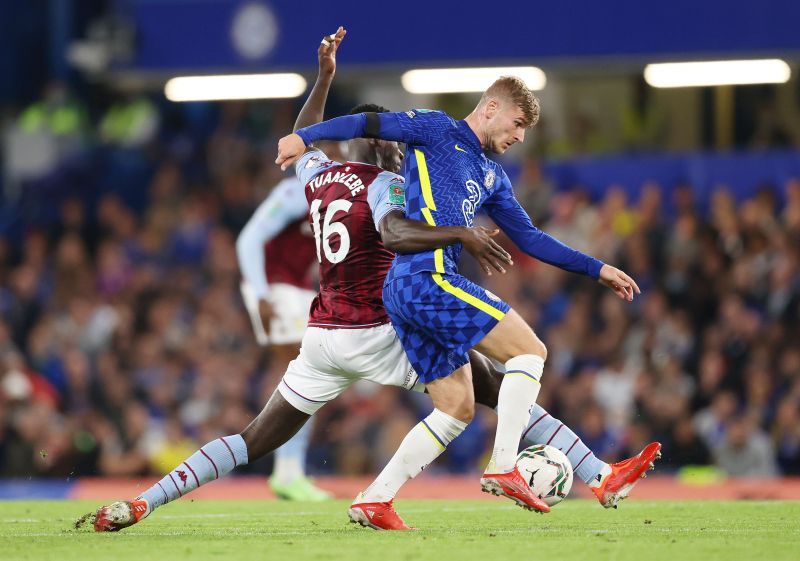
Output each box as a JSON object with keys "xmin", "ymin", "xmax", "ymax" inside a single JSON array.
[{"xmin": 361, "ymin": 409, "xmax": 467, "ymax": 503}]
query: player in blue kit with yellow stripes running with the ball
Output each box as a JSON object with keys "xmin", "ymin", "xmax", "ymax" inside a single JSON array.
[{"xmin": 276, "ymin": 76, "xmax": 644, "ymax": 512}]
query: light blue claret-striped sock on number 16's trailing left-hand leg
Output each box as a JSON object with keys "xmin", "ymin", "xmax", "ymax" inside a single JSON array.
[{"xmin": 138, "ymin": 434, "xmax": 247, "ymax": 511}]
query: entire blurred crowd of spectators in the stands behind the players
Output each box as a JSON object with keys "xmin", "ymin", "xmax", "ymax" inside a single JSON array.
[{"xmin": 0, "ymin": 91, "xmax": 800, "ymax": 477}]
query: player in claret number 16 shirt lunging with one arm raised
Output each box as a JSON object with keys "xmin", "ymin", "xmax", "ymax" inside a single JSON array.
[{"xmin": 94, "ymin": 29, "xmax": 653, "ymax": 531}]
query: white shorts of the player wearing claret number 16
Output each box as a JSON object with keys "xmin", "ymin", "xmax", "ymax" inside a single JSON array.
[{"xmin": 278, "ymin": 323, "xmax": 425, "ymax": 415}]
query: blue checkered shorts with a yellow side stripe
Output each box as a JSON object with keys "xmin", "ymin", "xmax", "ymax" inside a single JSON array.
[{"xmin": 383, "ymin": 272, "xmax": 510, "ymax": 384}]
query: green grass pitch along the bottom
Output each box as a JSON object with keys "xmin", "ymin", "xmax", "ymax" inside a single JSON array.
[{"xmin": 0, "ymin": 499, "xmax": 800, "ymax": 561}]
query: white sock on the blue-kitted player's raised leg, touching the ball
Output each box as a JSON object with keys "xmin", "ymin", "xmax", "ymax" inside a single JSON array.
[{"xmin": 486, "ymin": 355, "xmax": 544, "ymax": 473}]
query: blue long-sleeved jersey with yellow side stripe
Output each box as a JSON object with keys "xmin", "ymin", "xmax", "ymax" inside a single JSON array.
[{"xmin": 296, "ymin": 109, "xmax": 603, "ymax": 279}]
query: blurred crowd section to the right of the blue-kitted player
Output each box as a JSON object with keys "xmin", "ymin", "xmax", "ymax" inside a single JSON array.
[{"xmin": 490, "ymin": 172, "xmax": 800, "ymax": 476}]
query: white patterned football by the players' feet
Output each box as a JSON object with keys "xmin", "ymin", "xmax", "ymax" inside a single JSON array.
[{"xmin": 517, "ymin": 444, "xmax": 572, "ymax": 506}]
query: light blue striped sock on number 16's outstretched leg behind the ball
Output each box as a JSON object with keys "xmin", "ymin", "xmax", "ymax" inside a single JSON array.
[{"xmin": 522, "ymin": 404, "xmax": 607, "ymax": 484}]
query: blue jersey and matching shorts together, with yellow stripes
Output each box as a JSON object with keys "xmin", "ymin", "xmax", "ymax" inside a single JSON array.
[{"xmin": 297, "ymin": 109, "xmax": 603, "ymax": 383}]
